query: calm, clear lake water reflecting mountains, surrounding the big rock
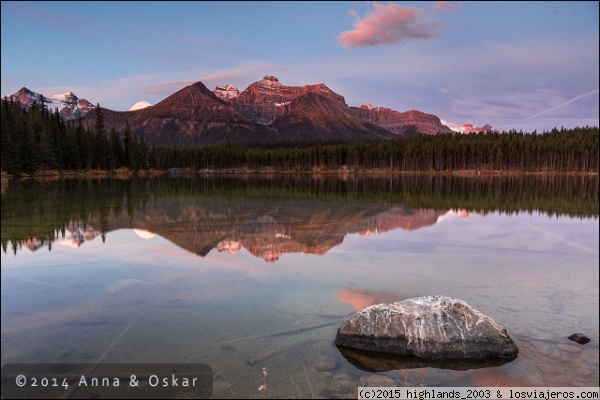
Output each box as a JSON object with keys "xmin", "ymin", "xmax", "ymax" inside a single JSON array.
[{"xmin": 1, "ymin": 174, "xmax": 599, "ymax": 398}]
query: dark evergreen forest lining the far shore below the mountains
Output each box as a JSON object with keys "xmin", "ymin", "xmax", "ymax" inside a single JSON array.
[{"xmin": 1, "ymin": 97, "xmax": 599, "ymax": 175}]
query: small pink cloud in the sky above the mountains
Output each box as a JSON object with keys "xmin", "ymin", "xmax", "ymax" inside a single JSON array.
[{"xmin": 337, "ymin": 1, "xmax": 459, "ymax": 49}]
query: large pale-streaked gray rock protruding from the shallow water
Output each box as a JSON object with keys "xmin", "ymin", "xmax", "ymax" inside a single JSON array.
[{"xmin": 335, "ymin": 296, "xmax": 519, "ymax": 359}]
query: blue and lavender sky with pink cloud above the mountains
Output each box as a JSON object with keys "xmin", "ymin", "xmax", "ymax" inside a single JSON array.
[{"xmin": 1, "ymin": 1, "xmax": 600, "ymax": 132}]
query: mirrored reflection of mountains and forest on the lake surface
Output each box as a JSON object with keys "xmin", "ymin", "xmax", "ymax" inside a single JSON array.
[{"xmin": 2, "ymin": 175, "xmax": 598, "ymax": 262}]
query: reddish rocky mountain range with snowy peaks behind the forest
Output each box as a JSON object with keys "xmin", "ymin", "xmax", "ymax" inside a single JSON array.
[{"xmin": 9, "ymin": 75, "xmax": 486, "ymax": 147}]
